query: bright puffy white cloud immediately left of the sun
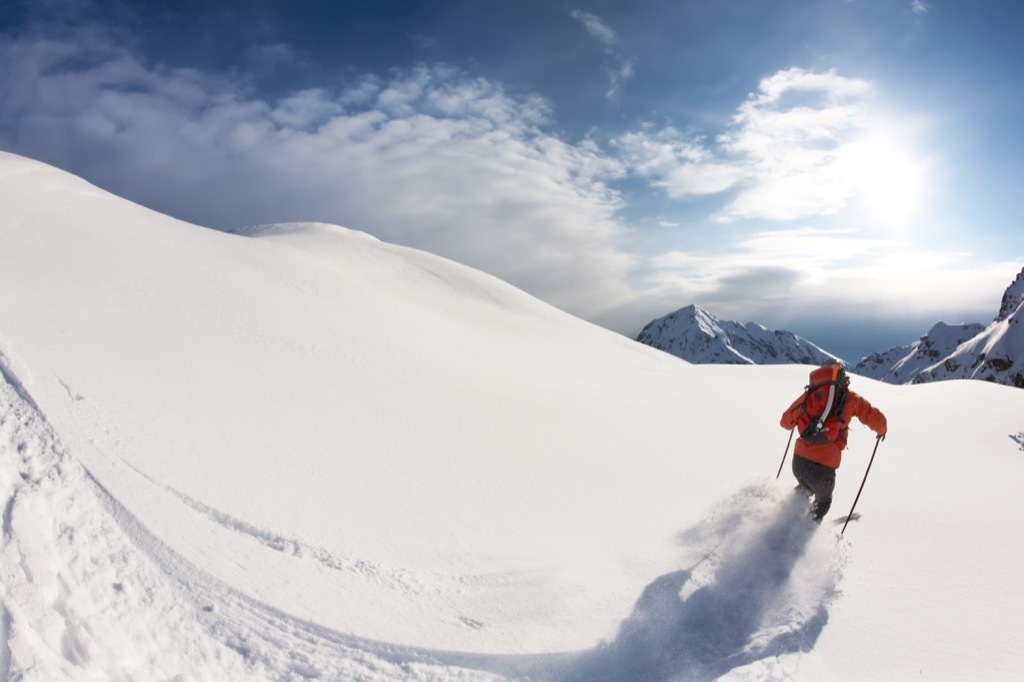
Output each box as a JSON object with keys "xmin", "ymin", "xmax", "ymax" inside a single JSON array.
[{"xmin": 616, "ymin": 68, "xmax": 871, "ymax": 222}]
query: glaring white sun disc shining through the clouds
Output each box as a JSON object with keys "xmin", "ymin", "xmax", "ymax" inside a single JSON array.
[{"xmin": 843, "ymin": 131, "xmax": 927, "ymax": 227}]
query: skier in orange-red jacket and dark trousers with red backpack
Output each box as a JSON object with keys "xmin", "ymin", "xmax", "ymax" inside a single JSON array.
[{"xmin": 779, "ymin": 364, "xmax": 887, "ymax": 522}]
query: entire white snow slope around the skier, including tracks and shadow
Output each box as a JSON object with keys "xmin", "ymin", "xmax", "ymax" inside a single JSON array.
[{"xmin": 0, "ymin": 155, "xmax": 1024, "ymax": 680}]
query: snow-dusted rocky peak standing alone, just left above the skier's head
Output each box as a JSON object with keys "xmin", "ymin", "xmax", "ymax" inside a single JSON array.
[{"xmin": 636, "ymin": 305, "xmax": 839, "ymax": 365}]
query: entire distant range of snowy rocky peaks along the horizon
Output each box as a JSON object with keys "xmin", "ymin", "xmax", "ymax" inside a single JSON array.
[{"xmin": 637, "ymin": 269, "xmax": 1024, "ymax": 388}]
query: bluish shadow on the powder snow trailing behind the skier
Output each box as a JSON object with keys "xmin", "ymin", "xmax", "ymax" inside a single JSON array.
[{"xmin": 522, "ymin": 487, "xmax": 830, "ymax": 682}]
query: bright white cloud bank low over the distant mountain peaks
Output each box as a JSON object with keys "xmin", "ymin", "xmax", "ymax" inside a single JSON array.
[{"xmin": 644, "ymin": 226, "xmax": 1020, "ymax": 333}]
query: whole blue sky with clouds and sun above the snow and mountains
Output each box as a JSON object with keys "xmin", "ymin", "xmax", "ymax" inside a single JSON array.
[{"xmin": 0, "ymin": 0, "xmax": 1024, "ymax": 361}]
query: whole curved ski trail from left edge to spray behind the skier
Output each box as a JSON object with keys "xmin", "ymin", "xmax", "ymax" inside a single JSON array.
[{"xmin": 0, "ymin": 363, "xmax": 847, "ymax": 682}]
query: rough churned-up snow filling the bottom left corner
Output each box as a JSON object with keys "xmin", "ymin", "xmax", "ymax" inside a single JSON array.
[{"xmin": 0, "ymin": 372, "xmax": 512, "ymax": 682}]
